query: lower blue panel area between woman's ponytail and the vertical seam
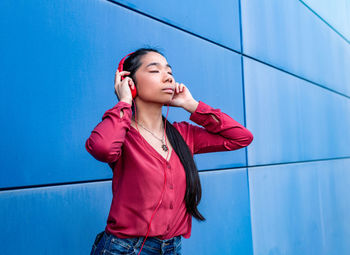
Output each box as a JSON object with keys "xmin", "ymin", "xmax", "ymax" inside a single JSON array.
[{"xmin": 182, "ymin": 168, "xmax": 253, "ymax": 255}]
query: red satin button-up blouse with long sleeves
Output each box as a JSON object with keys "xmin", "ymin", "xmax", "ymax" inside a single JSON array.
[{"xmin": 85, "ymin": 101, "xmax": 253, "ymax": 240}]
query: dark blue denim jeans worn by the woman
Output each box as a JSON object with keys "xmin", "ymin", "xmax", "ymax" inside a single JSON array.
[{"xmin": 90, "ymin": 231, "xmax": 181, "ymax": 255}]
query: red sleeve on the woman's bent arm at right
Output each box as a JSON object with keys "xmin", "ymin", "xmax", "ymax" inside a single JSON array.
[{"xmin": 174, "ymin": 101, "xmax": 253, "ymax": 154}]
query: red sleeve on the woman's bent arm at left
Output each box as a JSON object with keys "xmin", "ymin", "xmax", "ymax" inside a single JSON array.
[{"xmin": 85, "ymin": 101, "xmax": 132, "ymax": 163}]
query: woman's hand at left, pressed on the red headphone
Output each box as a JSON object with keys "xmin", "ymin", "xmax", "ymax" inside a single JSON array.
[{"xmin": 114, "ymin": 70, "xmax": 135, "ymax": 104}]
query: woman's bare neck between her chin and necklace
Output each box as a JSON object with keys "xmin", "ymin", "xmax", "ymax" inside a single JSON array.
[{"xmin": 133, "ymin": 98, "xmax": 164, "ymax": 133}]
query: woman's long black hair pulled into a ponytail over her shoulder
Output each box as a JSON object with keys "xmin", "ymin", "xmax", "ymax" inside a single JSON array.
[{"xmin": 123, "ymin": 47, "xmax": 206, "ymax": 221}]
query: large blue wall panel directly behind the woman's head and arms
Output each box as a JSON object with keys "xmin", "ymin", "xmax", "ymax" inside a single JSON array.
[{"xmin": 0, "ymin": 0, "xmax": 245, "ymax": 188}]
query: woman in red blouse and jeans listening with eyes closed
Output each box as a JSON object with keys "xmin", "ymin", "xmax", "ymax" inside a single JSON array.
[{"xmin": 85, "ymin": 48, "xmax": 253, "ymax": 255}]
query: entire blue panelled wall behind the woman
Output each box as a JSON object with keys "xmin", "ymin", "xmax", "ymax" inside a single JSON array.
[{"xmin": 0, "ymin": 0, "xmax": 350, "ymax": 255}]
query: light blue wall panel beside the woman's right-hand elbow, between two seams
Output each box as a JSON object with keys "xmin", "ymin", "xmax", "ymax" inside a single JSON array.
[{"xmin": 243, "ymin": 57, "xmax": 350, "ymax": 165}]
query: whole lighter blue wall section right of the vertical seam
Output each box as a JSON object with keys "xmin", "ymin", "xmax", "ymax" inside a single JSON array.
[{"xmin": 242, "ymin": 0, "xmax": 350, "ymax": 255}]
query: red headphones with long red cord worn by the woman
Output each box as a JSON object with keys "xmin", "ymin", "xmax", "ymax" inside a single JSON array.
[{"xmin": 118, "ymin": 52, "xmax": 170, "ymax": 255}]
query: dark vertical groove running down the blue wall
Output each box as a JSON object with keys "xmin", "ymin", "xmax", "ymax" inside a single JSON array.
[{"xmin": 238, "ymin": 0, "xmax": 254, "ymax": 254}]
